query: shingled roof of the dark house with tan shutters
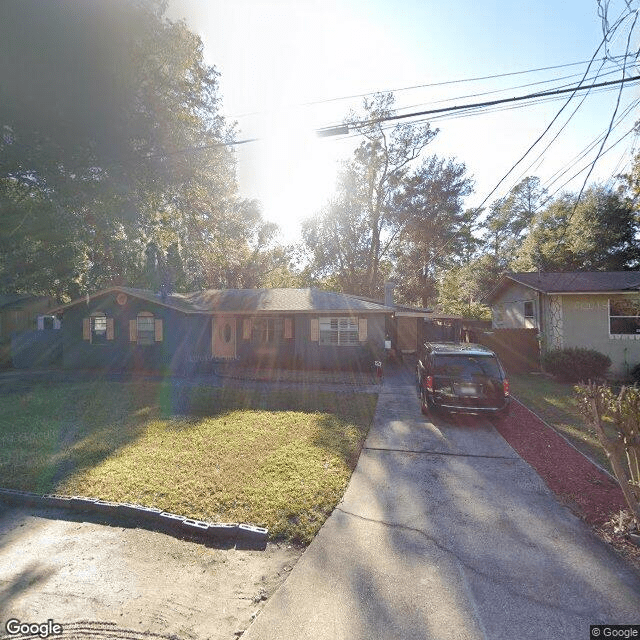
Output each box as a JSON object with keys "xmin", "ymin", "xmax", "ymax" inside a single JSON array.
[{"xmin": 56, "ymin": 287, "xmax": 393, "ymax": 314}]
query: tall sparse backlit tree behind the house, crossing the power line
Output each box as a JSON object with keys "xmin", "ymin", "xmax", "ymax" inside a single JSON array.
[{"xmin": 303, "ymin": 93, "xmax": 437, "ymax": 296}]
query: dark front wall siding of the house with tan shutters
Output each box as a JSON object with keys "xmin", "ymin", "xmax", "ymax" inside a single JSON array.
[{"xmin": 62, "ymin": 291, "xmax": 385, "ymax": 374}]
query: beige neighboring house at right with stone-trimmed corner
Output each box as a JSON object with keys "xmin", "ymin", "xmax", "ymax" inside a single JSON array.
[{"xmin": 485, "ymin": 271, "xmax": 640, "ymax": 376}]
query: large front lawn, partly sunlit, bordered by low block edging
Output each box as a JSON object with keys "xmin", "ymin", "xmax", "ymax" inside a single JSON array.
[{"xmin": 0, "ymin": 382, "xmax": 376, "ymax": 543}]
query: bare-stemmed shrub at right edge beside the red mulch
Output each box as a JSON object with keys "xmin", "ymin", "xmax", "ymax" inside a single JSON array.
[{"xmin": 576, "ymin": 383, "xmax": 640, "ymax": 526}]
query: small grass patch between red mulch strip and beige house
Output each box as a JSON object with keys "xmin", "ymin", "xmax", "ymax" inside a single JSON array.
[{"xmin": 509, "ymin": 374, "xmax": 613, "ymax": 473}]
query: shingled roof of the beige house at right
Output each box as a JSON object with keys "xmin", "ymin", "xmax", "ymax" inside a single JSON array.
[{"xmin": 485, "ymin": 271, "xmax": 640, "ymax": 303}]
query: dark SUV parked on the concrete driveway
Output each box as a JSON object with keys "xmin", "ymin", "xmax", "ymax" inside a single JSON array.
[{"xmin": 416, "ymin": 342, "xmax": 511, "ymax": 419}]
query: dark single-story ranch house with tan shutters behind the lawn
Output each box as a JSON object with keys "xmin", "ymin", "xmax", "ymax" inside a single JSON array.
[{"xmin": 52, "ymin": 287, "xmax": 394, "ymax": 373}]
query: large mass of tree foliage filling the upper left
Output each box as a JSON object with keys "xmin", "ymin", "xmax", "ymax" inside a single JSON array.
[{"xmin": 0, "ymin": 0, "xmax": 280, "ymax": 299}]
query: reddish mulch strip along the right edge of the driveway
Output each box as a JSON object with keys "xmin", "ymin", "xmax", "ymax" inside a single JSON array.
[{"xmin": 496, "ymin": 402, "xmax": 640, "ymax": 570}]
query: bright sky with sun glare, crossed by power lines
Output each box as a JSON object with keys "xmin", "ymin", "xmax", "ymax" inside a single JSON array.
[{"xmin": 168, "ymin": 0, "xmax": 640, "ymax": 242}]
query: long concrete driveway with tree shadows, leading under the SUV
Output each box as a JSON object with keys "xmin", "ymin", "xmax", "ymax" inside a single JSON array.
[{"xmin": 243, "ymin": 362, "xmax": 640, "ymax": 640}]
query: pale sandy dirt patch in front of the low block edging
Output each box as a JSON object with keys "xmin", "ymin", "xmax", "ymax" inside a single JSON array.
[{"xmin": 0, "ymin": 505, "xmax": 302, "ymax": 640}]
